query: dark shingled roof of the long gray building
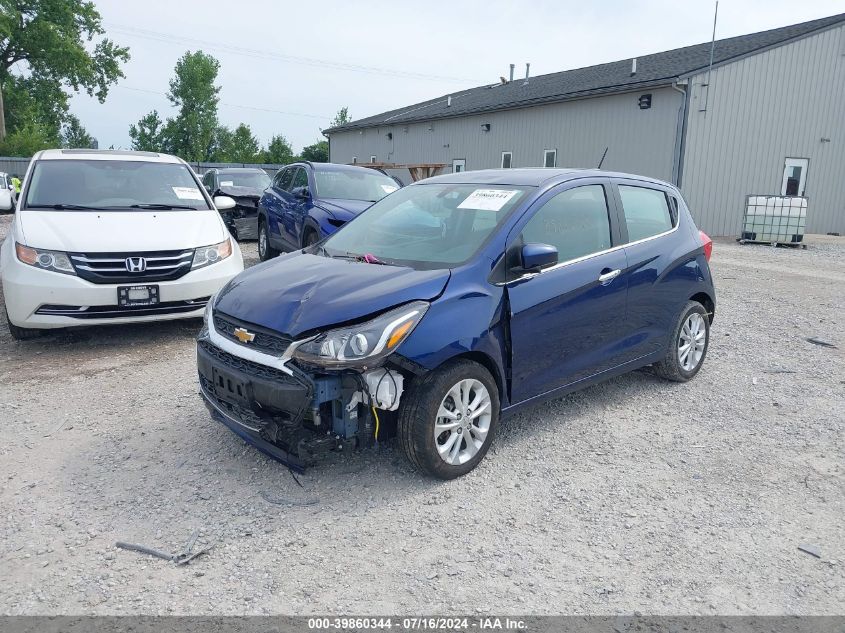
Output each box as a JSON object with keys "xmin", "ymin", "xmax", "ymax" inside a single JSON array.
[{"xmin": 324, "ymin": 13, "xmax": 845, "ymax": 134}]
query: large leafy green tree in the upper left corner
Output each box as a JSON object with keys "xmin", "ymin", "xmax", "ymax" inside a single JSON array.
[{"xmin": 0, "ymin": 0, "xmax": 129, "ymax": 143}]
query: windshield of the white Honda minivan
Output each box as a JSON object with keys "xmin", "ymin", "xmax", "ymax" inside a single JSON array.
[{"xmin": 26, "ymin": 159, "xmax": 209, "ymax": 211}]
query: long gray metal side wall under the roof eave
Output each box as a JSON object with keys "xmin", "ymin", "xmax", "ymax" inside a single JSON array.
[{"xmin": 330, "ymin": 88, "xmax": 682, "ymax": 181}]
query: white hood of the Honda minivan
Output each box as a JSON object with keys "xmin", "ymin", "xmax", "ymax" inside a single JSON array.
[{"xmin": 18, "ymin": 210, "xmax": 227, "ymax": 253}]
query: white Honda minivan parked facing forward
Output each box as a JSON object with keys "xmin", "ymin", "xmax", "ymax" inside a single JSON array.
[{"xmin": 0, "ymin": 150, "xmax": 243, "ymax": 339}]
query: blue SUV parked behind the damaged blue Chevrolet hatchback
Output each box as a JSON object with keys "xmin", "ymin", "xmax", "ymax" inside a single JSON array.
[{"xmin": 258, "ymin": 161, "xmax": 399, "ymax": 261}]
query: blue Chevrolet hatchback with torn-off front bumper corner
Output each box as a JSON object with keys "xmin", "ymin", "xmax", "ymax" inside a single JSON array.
[{"xmin": 197, "ymin": 169, "xmax": 715, "ymax": 479}]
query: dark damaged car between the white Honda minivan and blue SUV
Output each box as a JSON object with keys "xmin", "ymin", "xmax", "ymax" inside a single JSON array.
[{"xmin": 202, "ymin": 167, "xmax": 270, "ymax": 240}]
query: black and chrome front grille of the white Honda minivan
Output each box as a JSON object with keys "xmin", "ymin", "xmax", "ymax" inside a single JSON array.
[{"xmin": 70, "ymin": 249, "xmax": 194, "ymax": 284}]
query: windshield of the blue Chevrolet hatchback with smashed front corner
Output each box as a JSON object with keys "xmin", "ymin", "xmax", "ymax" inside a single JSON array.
[{"xmin": 323, "ymin": 184, "xmax": 528, "ymax": 269}]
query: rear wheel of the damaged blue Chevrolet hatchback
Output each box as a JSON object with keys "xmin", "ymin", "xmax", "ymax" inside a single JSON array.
[{"xmin": 654, "ymin": 301, "xmax": 710, "ymax": 382}]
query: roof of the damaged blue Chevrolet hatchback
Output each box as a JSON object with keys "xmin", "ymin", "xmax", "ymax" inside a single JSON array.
[{"xmin": 414, "ymin": 167, "xmax": 674, "ymax": 187}]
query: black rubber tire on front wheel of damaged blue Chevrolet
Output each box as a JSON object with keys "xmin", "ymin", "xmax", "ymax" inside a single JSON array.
[{"xmin": 397, "ymin": 360, "xmax": 499, "ymax": 479}]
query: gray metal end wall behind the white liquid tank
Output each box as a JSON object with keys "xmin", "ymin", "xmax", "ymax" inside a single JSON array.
[{"xmin": 681, "ymin": 22, "xmax": 845, "ymax": 235}]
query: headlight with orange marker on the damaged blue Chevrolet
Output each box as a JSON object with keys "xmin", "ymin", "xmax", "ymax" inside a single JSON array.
[{"xmin": 293, "ymin": 301, "xmax": 428, "ymax": 368}]
